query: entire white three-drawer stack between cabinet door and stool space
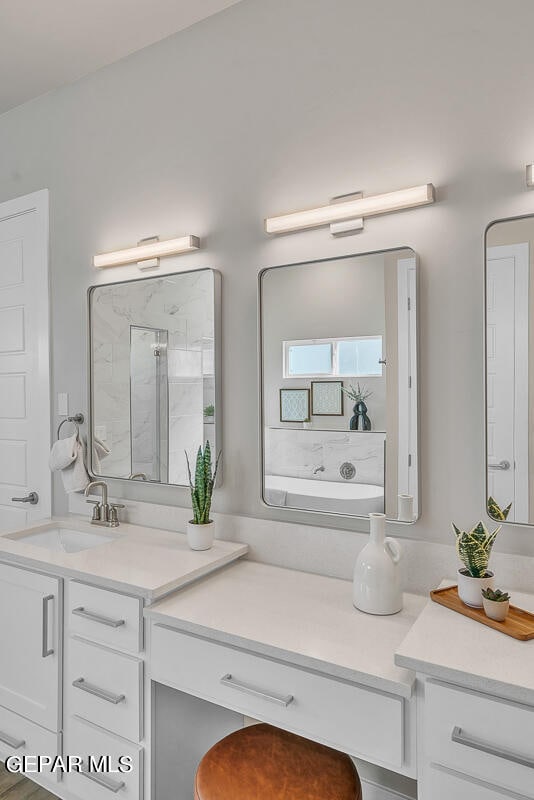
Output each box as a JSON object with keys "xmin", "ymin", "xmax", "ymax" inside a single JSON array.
[{"xmin": 63, "ymin": 580, "xmax": 146, "ymax": 800}]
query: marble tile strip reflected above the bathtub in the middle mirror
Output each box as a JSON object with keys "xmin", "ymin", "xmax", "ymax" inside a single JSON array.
[{"xmin": 265, "ymin": 428, "xmax": 386, "ymax": 486}]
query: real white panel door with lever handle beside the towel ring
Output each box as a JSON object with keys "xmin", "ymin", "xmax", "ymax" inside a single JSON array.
[{"xmin": 0, "ymin": 190, "xmax": 51, "ymax": 531}]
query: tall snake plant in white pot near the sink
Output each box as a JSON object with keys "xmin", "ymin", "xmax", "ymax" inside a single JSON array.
[{"xmin": 185, "ymin": 442, "xmax": 221, "ymax": 550}]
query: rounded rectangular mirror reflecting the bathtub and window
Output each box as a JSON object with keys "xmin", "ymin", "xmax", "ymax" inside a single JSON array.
[{"xmin": 259, "ymin": 248, "xmax": 419, "ymax": 522}]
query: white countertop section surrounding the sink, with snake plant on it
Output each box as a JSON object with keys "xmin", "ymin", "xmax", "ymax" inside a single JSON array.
[{"xmin": 0, "ymin": 516, "xmax": 248, "ymax": 602}]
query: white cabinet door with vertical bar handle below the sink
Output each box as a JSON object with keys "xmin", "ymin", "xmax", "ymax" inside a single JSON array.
[{"xmin": 0, "ymin": 564, "xmax": 61, "ymax": 731}]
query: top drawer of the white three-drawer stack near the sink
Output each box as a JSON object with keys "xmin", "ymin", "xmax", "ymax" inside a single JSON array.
[{"xmin": 67, "ymin": 581, "xmax": 143, "ymax": 653}]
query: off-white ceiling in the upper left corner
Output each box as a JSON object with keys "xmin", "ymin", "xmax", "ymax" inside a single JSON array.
[{"xmin": 0, "ymin": 0, "xmax": 238, "ymax": 114}]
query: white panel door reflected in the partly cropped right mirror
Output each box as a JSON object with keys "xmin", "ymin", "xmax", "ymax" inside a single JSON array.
[{"xmin": 486, "ymin": 243, "xmax": 529, "ymax": 522}]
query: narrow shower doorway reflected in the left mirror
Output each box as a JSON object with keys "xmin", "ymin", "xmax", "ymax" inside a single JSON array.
[{"xmin": 130, "ymin": 325, "xmax": 169, "ymax": 483}]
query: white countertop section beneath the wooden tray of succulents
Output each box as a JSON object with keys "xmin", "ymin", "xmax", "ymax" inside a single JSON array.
[{"xmin": 395, "ymin": 581, "xmax": 534, "ymax": 704}]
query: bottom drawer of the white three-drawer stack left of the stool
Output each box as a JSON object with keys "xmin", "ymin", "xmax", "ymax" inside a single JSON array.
[{"xmin": 63, "ymin": 717, "xmax": 143, "ymax": 800}]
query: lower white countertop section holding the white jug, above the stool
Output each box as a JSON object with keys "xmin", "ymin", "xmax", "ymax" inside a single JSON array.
[{"xmin": 145, "ymin": 561, "xmax": 426, "ymax": 697}]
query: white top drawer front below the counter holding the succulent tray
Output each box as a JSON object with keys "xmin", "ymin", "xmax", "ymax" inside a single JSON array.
[{"xmin": 430, "ymin": 681, "xmax": 534, "ymax": 797}]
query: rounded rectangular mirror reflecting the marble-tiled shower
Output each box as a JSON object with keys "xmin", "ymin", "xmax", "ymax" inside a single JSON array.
[{"xmin": 89, "ymin": 269, "xmax": 220, "ymax": 486}]
